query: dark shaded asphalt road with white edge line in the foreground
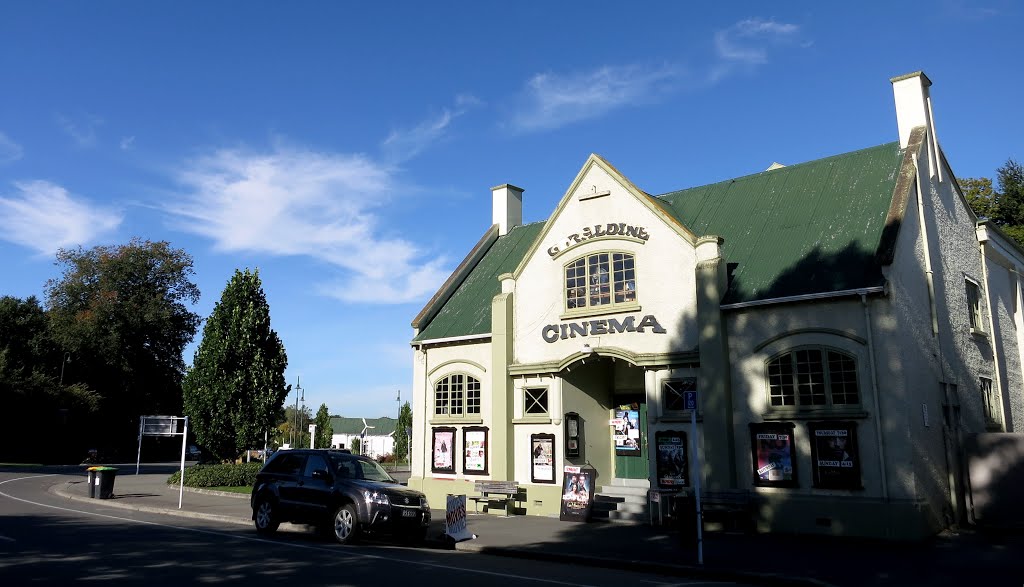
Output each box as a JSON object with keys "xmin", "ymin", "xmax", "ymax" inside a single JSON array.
[{"xmin": 0, "ymin": 469, "xmax": 757, "ymax": 587}]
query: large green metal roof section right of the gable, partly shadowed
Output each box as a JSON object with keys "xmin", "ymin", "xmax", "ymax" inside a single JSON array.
[{"xmin": 657, "ymin": 142, "xmax": 903, "ymax": 304}]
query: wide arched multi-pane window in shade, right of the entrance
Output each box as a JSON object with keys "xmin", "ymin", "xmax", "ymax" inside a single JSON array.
[{"xmin": 768, "ymin": 347, "xmax": 860, "ymax": 408}]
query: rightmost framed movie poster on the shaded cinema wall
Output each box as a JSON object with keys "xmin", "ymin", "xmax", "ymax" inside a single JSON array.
[{"xmin": 807, "ymin": 422, "xmax": 863, "ymax": 489}]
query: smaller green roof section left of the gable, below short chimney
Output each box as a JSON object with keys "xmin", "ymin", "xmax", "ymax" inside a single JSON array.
[{"xmin": 413, "ymin": 222, "xmax": 544, "ymax": 342}]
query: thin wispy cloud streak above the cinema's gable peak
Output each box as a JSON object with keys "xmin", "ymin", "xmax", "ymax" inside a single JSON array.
[{"xmin": 512, "ymin": 66, "xmax": 680, "ymax": 131}]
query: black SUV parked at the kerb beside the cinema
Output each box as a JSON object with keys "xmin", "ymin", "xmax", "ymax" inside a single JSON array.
[{"xmin": 250, "ymin": 449, "xmax": 430, "ymax": 544}]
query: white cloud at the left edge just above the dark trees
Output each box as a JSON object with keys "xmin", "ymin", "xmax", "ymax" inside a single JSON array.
[{"xmin": 0, "ymin": 180, "xmax": 122, "ymax": 254}]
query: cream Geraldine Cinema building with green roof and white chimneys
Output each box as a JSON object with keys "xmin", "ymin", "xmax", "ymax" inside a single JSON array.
[{"xmin": 410, "ymin": 72, "xmax": 1024, "ymax": 538}]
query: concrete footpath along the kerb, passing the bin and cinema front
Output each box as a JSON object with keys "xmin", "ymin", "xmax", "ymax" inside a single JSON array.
[{"xmin": 51, "ymin": 467, "xmax": 1024, "ymax": 587}]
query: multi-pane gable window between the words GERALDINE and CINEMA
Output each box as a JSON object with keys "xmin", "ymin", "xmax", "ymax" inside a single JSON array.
[{"xmin": 565, "ymin": 253, "xmax": 637, "ymax": 309}]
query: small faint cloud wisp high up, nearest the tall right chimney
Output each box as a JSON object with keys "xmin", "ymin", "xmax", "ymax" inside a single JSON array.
[{"xmin": 711, "ymin": 18, "xmax": 800, "ymax": 81}]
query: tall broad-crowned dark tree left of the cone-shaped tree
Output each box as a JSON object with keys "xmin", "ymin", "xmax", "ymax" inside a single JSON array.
[{"xmin": 46, "ymin": 239, "xmax": 200, "ymax": 454}]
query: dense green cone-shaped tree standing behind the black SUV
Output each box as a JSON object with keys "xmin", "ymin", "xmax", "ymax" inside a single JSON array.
[{"xmin": 184, "ymin": 269, "xmax": 291, "ymax": 460}]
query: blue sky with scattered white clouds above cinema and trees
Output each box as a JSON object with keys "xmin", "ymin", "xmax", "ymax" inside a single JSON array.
[{"xmin": 0, "ymin": 0, "xmax": 1024, "ymax": 417}]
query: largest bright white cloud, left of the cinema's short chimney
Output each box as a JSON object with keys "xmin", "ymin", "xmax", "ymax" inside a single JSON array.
[{"xmin": 167, "ymin": 146, "xmax": 446, "ymax": 303}]
